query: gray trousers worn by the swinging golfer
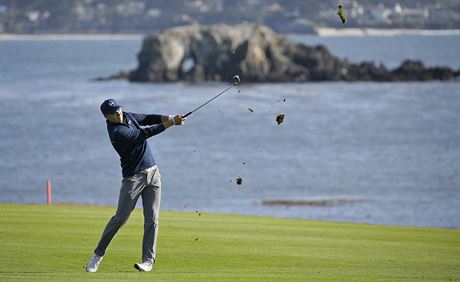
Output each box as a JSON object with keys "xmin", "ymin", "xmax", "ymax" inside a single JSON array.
[{"xmin": 94, "ymin": 166, "xmax": 161, "ymax": 263}]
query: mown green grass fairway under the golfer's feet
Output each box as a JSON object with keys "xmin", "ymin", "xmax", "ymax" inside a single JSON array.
[{"xmin": 0, "ymin": 204, "xmax": 460, "ymax": 281}]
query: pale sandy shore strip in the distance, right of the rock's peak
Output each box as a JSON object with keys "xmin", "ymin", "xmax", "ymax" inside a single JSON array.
[{"xmin": 315, "ymin": 27, "xmax": 460, "ymax": 36}]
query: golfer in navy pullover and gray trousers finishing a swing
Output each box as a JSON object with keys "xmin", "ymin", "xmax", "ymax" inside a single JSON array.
[{"xmin": 86, "ymin": 99, "xmax": 185, "ymax": 272}]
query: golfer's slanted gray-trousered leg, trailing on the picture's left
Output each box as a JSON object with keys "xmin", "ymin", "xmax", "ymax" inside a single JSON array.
[{"xmin": 94, "ymin": 175, "xmax": 146, "ymax": 256}]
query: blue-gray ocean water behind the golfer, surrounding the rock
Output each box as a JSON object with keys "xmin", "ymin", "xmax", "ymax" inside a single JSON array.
[{"xmin": 0, "ymin": 36, "xmax": 460, "ymax": 228}]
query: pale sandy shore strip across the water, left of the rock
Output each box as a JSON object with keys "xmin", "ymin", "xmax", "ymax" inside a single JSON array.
[{"xmin": 0, "ymin": 33, "xmax": 144, "ymax": 41}]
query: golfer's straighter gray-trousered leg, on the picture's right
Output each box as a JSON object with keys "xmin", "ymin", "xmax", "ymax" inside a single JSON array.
[{"xmin": 142, "ymin": 168, "xmax": 161, "ymax": 263}]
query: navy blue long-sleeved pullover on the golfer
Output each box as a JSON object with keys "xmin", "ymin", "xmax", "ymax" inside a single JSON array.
[{"xmin": 107, "ymin": 112, "xmax": 165, "ymax": 178}]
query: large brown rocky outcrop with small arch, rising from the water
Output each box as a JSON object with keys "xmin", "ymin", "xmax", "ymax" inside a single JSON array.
[{"xmin": 112, "ymin": 24, "xmax": 460, "ymax": 82}]
